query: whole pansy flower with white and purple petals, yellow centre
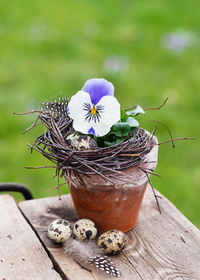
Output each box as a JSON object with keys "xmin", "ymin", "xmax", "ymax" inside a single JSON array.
[{"xmin": 68, "ymin": 79, "xmax": 120, "ymax": 136}]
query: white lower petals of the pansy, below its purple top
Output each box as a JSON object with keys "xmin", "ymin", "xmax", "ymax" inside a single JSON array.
[{"xmin": 68, "ymin": 87, "xmax": 120, "ymax": 136}]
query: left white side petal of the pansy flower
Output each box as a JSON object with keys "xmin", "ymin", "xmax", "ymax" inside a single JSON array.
[{"xmin": 68, "ymin": 91, "xmax": 92, "ymax": 121}]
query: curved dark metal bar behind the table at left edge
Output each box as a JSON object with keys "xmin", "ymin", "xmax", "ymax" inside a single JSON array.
[{"xmin": 0, "ymin": 183, "xmax": 33, "ymax": 200}]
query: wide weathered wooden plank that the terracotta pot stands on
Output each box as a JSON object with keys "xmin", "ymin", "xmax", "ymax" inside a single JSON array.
[{"xmin": 19, "ymin": 186, "xmax": 200, "ymax": 280}]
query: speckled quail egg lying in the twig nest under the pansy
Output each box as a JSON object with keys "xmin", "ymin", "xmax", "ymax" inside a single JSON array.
[{"xmin": 66, "ymin": 133, "xmax": 97, "ymax": 150}]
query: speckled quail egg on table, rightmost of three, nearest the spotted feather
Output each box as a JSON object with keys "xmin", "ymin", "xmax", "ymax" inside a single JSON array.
[{"xmin": 97, "ymin": 229, "xmax": 126, "ymax": 255}]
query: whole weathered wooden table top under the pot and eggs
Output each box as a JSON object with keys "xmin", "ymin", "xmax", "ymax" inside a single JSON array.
[{"xmin": 0, "ymin": 185, "xmax": 200, "ymax": 280}]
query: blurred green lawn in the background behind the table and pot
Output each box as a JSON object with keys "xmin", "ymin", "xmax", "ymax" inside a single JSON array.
[{"xmin": 0, "ymin": 0, "xmax": 200, "ymax": 227}]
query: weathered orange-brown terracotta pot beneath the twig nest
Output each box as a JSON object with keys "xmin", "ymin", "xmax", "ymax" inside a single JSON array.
[{"xmin": 70, "ymin": 132, "xmax": 158, "ymax": 233}]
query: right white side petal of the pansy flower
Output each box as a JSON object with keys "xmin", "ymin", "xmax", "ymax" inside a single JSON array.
[{"xmin": 97, "ymin": 96, "xmax": 121, "ymax": 127}]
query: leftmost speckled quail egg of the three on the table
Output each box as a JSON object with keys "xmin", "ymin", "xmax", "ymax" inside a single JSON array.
[{"xmin": 48, "ymin": 219, "xmax": 72, "ymax": 243}]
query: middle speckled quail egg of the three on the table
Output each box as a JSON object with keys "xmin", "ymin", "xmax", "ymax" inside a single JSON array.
[{"xmin": 73, "ymin": 219, "xmax": 97, "ymax": 240}]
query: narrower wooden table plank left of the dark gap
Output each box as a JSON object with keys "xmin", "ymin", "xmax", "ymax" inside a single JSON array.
[{"xmin": 0, "ymin": 195, "xmax": 61, "ymax": 280}]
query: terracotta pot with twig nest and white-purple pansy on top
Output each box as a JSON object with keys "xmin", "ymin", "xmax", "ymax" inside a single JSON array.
[{"xmin": 18, "ymin": 79, "xmax": 161, "ymax": 232}]
